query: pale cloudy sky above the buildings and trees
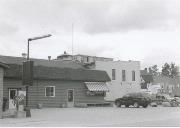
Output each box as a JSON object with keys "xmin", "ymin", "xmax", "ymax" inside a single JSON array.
[{"xmin": 0, "ymin": 0, "xmax": 180, "ymax": 69}]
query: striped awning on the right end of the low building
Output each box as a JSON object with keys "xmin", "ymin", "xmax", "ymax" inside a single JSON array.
[{"xmin": 85, "ymin": 82, "xmax": 109, "ymax": 92}]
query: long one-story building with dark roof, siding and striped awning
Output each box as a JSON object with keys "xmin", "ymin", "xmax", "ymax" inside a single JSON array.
[{"xmin": 0, "ymin": 56, "xmax": 110, "ymax": 109}]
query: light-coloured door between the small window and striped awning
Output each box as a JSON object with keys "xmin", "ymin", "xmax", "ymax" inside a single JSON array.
[{"xmin": 67, "ymin": 89, "xmax": 74, "ymax": 107}]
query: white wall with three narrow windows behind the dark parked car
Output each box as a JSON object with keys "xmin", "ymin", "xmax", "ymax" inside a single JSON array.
[{"xmin": 95, "ymin": 61, "xmax": 140, "ymax": 100}]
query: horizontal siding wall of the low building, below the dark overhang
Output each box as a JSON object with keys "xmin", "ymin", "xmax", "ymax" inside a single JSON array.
[{"xmin": 4, "ymin": 78, "xmax": 104, "ymax": 108}]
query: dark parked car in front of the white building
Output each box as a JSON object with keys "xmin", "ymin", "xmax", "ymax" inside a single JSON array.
[{"xmin": 115, "ymin": 93, "xmax": 151, "ymax": 108}]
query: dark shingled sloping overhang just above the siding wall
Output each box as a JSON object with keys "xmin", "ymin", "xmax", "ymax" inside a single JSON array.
[{"xmin": 4, "ymin": 64, "xmax": 110, "ymax": 82}]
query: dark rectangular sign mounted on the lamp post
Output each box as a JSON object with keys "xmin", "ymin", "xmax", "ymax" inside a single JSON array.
[{"xmin": 22, "ymin": 60, "xmax": 33, "ymax": 86}]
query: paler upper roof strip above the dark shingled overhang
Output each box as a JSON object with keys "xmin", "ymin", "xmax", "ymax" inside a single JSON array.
[{"xmin": 0, "ymin": 55, "xmax": 84, "ymax": 69}]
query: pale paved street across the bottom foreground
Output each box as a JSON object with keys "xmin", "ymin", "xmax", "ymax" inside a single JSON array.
[{"xmin": 0, "ymin": 107, "xmax": 180, "ymax": 127}]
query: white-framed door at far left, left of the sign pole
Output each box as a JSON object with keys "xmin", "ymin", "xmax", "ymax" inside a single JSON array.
[{"xmin": 9, "ymin": 89, "xmax": 17, "ymax": 109}]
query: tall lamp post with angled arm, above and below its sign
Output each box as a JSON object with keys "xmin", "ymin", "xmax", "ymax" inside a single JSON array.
[{"xmin": 26, "ymin": 34, "xmax": 52, "ymax": 117}]
